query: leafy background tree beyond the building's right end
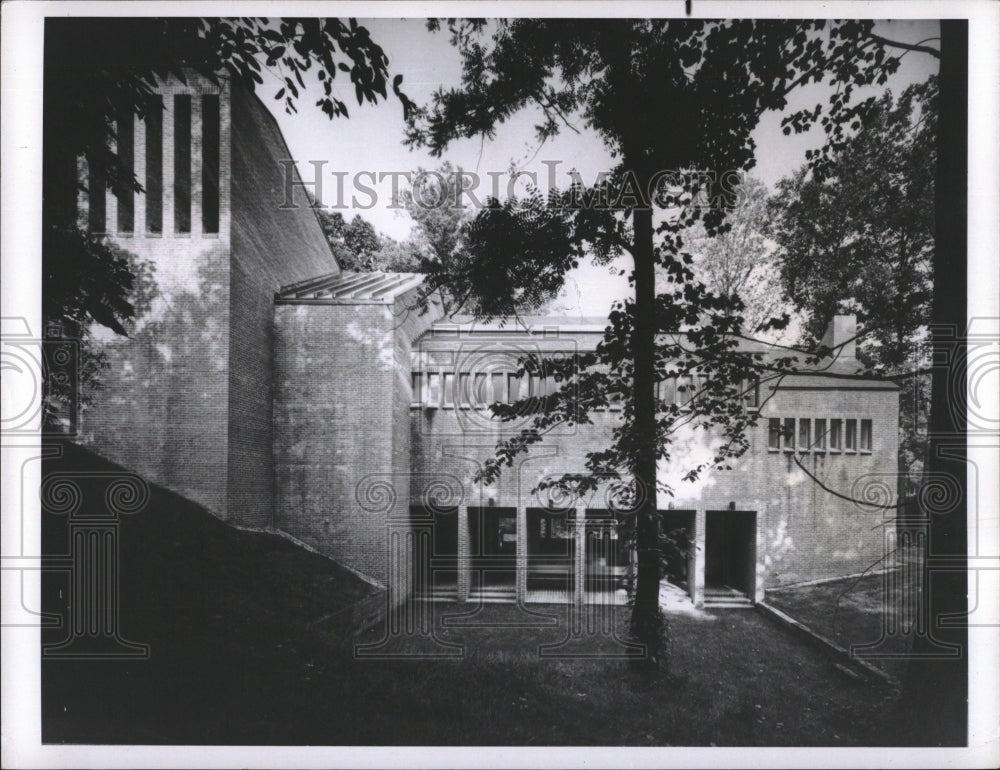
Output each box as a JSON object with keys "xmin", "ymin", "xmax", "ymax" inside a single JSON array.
[{"xmin": 769, "ymin": 78, "xmax": 938, "ymax": 480}]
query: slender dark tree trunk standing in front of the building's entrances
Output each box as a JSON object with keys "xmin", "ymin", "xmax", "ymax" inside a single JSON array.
[{"xmin": 631, "ymin": 196, "xmax": 663, "ymax": 662}]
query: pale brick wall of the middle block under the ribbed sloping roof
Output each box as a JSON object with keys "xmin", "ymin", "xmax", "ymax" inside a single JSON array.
[{"xmin": 274, "ymin": 292, "xmax": 434, "ymax": 584}]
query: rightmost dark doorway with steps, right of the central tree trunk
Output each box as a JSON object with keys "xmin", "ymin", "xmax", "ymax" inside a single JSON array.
[{"xmin": 705, "ymin": 511, "xmax": 757, "ymax": 599}]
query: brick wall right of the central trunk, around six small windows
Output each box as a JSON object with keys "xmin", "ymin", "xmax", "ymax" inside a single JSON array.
[{"xmin": 660, "ymin": 380, "xmax": 899, "ymax": 587}]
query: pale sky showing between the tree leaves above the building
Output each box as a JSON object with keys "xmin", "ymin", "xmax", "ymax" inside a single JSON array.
[{"xmin": 259, "ymin": 19, "xmax": 938, "ymax": 316}]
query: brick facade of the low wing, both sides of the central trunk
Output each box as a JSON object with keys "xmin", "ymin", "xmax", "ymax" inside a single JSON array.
[{"xmin": 411, "ymin": 322, "xmax": 898, "ymax": 587}]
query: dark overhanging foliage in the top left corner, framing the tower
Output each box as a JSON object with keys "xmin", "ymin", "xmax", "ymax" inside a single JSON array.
[{"xmin": 42, "ymin": 18, "xmax": 411, "ymax": 416}]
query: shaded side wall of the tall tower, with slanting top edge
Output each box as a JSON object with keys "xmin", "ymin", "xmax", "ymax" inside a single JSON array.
[{"xmin": 227, "ymin": 88, "xmax": 339, "ymax": 527}]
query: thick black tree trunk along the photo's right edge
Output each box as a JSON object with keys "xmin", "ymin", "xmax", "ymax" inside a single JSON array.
[{"xmin": 899, "ymin": 20, "xmax": 969, "ymax": 746}]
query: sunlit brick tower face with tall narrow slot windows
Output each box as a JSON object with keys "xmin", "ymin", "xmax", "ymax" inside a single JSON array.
[{"xmin": 79, "ymin": 73, "xmax": 230, "ymax": 517}]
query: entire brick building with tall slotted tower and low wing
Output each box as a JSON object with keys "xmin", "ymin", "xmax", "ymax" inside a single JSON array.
[{"xmin": 72, "ymin": 77, "xmax": 898, "ymax": 603}]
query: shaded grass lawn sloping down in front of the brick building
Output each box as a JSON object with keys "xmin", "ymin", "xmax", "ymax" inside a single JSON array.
[{"xmin": 42, "ymin": 444, "xmax": 908, "ymax": 746}]
